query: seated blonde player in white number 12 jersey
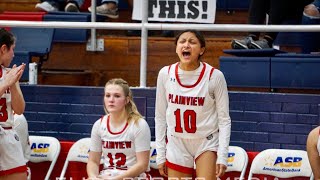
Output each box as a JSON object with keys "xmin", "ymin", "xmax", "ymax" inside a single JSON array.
[{"xmin": 87, "ymin": 79, "xmax": 151, "ymax": 179}]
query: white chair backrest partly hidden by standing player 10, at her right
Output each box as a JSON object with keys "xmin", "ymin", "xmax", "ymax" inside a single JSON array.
[{"xmin": 226, "ymin": 146, "xmax": 248, "ymax": 180}]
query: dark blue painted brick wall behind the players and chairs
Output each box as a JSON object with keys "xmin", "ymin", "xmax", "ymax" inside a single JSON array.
[{"xmin": 21, "ymin": 85, "xmax": 320, "ymax": 151}]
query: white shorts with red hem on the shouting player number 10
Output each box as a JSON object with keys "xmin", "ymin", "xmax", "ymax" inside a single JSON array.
[{"xmin": 166, "ymin": 132, "xmax": 219, "ymax": 174}]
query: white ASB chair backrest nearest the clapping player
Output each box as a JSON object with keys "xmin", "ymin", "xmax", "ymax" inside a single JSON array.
[{"xmin": 29, "ymin": 136, "xmax": 61, "ymax": 180}]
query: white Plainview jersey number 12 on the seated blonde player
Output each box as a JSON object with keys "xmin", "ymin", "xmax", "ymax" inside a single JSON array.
[{"xmin": 99, "ymin": 115, "xmax": 150, "ymax": 170}]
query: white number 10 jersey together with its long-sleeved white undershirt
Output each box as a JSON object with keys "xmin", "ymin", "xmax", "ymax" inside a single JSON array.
[{"xmin": 155, "ymin": 62, "xmax": 231, "ymax": 165}]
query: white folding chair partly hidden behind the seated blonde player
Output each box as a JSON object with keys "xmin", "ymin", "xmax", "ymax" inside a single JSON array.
[{"xmin": 60, "ymin": 138, "xmax": 103, "ymax": 179}]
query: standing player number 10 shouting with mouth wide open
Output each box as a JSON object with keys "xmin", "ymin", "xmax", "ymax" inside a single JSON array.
[{"xmin": 155, "ymin": 30, "xmax": 231, "ymax": 180}]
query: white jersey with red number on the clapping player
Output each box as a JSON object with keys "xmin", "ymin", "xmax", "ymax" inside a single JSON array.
[{"xmin": 0, "ymin": 66, "xmax": 14, "ymax": 127}]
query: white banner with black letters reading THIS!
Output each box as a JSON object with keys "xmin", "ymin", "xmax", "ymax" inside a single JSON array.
[{"xmin": 132, "ymin": 0, "xmax": 216, "ymax": 23}]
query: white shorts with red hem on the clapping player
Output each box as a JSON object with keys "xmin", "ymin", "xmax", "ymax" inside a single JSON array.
[{"xmin": 0, "ymin": 126, "xmax": 27, "ymax": 176}]
